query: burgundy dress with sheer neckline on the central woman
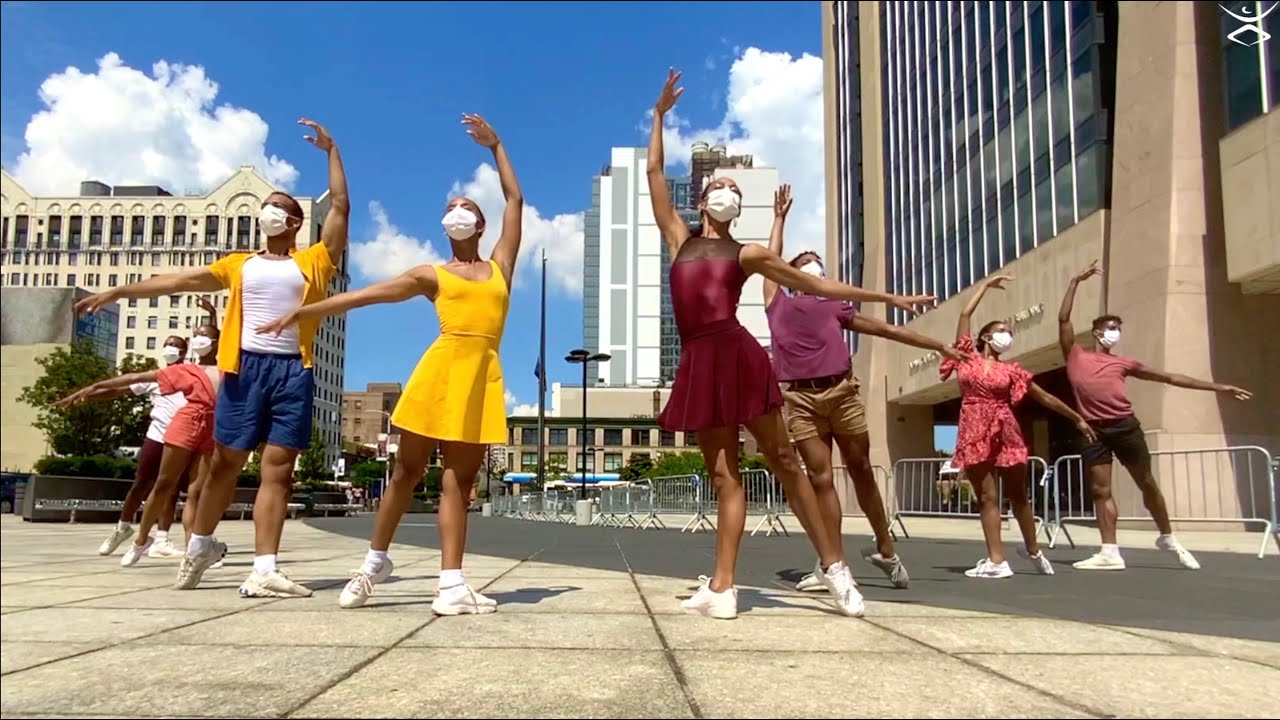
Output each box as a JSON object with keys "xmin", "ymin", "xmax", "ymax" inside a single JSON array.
[{"xmin": 658, "ymin": 237, "xmax": 782, "ymax": 432}]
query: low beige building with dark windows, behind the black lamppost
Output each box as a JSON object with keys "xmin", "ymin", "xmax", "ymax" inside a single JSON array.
[{"xmin": 506, "ymin": 383, "xmax": 758, "ymax": 473}]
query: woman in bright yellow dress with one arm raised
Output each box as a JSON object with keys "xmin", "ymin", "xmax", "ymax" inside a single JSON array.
[{"xmin": 257, "ymin": 115, "xmax": 525, "ymax": 615}]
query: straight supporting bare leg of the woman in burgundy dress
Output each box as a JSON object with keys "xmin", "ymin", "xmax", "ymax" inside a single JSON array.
[{"xmin": 698, "ymin": 428, "xmax": 746, "ymax": 592}]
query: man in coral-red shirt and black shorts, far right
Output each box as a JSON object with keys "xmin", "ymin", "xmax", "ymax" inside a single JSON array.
[{"xmin": 1057, "ymin": 260, "xmax": 1253, "ymax": 570}]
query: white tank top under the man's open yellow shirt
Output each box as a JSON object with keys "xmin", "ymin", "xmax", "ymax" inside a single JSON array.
[{"xmin": 241, "ymin": 258, "xmax": 306, "ymax": 355}]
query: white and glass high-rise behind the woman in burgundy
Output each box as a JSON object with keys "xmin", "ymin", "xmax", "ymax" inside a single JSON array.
[{"xmin": 582, "ymin": 142, "xmax": 778, "ymax": 387}]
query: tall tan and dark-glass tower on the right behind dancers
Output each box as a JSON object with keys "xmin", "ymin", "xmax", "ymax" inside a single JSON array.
[{"xmin": 823, "ymin": 1, "xmax": 1280, "ymax": 491}]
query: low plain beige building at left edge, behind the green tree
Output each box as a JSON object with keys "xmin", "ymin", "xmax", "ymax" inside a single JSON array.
[{"xmin": 0, "ymin": 287, "xmax": 119, "ymax": 473}]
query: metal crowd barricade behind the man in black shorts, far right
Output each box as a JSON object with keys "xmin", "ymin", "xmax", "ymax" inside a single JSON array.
[{"xmin": 1043, "ymin": 446, "xmax": 1280, "ymax": 559}]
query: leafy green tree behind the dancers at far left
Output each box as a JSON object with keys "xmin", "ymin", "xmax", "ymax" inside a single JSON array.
[{"xmin": 18, "ymin": 341, "xmax": 155, "ymax": 455}]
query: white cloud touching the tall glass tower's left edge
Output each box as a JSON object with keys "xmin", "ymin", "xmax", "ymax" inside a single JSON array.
[{"xmin": 644, "ymin": 47, "xmax": 826, "ymax": 247}]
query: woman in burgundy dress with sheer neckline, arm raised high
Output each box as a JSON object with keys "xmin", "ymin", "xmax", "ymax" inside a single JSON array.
[{"xmin": 648, "ymin": 70, "xmax": 932, "ymax": 619}]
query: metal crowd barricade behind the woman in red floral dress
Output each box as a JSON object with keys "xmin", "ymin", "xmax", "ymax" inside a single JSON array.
[{"xmin": 890, "ymin": 456, "xmax": 1048, "ymax": 538}]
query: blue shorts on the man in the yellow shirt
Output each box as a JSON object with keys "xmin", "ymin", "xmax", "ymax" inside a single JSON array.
[{"xmin": 214, "ymin": 351, "xmax": 315, "ymax": 450}]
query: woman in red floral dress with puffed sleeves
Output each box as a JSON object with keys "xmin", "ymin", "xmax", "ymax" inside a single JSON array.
[{"xmin": 940, "ymin": 275, "xmax": 1093, "ymax": 579}]
